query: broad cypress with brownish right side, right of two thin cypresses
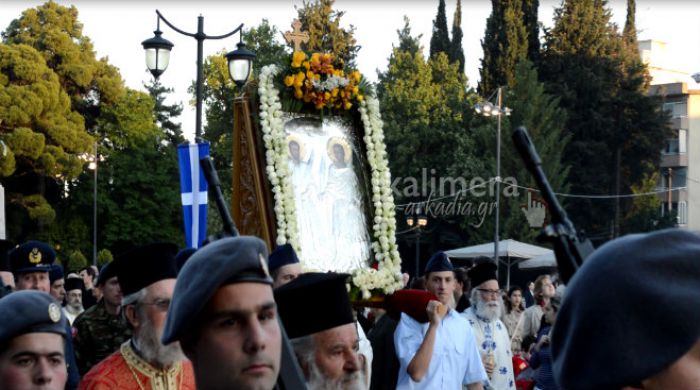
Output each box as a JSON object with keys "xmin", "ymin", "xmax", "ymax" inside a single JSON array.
[{"xmin": 479, "ymin": 0, "xmax": 528, "ymax": 95}]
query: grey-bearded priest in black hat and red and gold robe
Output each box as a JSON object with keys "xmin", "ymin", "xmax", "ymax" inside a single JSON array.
[{"xmin": 80, "ymin": 243, "xmax": 195, "ymax": 390}]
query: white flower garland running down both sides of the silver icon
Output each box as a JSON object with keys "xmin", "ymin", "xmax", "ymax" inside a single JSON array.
[{"xmin": 258, "ymin": 65, "xmax": 403, "ymax": 299}]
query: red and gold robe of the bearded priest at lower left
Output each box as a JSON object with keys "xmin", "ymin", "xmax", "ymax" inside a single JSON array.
[{"xmin": 78, "ymin": 340, "xmax": 196, "ymax": 390}]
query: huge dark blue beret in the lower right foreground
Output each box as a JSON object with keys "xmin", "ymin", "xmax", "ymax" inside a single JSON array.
[{"xmin": 552, "ymin": 229, "xmax": 700, "ymax": 390}]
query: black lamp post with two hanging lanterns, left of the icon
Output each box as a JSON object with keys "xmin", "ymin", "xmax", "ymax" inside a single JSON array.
[{"xmin": 141, "ymin": 10, "xmax": 255, "ymax": 141}]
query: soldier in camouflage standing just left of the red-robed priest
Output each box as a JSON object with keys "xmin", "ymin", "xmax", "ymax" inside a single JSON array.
[{"xmin": 73, "ymin": 263, "xmax": 131, "ymax": 374}]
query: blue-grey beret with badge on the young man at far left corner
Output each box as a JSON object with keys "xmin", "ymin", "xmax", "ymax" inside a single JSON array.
[{"xmin": 0, "ymin": 290, "xmax": 66, "ymax": 346}]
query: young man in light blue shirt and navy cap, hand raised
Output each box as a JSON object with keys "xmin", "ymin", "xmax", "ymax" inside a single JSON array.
[{"xmin": 394, "ymin": 252, "xmax": 487, "ymax": 390}]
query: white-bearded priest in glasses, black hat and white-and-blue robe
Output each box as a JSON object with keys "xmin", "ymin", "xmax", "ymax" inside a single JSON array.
[{"xmin": 462, "ymin": 262, "xmax": 515, "ymax": 390}]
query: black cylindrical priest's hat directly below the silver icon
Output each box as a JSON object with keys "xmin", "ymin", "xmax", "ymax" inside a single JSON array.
[{"xmin": 275, "ymin": 272, "xmax": 355, "ymax": 339}]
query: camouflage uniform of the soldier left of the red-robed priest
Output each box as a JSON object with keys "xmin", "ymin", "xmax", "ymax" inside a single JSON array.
[{"xmin": 73, "ymin": 300, "xmax": 131, "ymax": 375}]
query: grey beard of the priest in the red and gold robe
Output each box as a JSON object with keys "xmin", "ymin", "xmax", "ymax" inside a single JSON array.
[{"xmin": 134, "ymin": 315, "xmax": 185, "ymax": 368}]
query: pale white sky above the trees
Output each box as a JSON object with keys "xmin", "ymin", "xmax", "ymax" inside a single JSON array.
[{"xmin": 0, "ymin": 0, "xmax": 700, "ymax": 139}]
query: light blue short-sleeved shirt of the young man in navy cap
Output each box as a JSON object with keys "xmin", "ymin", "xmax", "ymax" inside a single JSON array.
[{"xmin": 394, "ymin": 310, "xmax": 487, "ymax": 390}]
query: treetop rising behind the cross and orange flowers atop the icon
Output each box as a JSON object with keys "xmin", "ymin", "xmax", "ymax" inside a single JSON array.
[{"xmin": 297, "ymin": 0, "xmax": 360, "ymax": 68}]
